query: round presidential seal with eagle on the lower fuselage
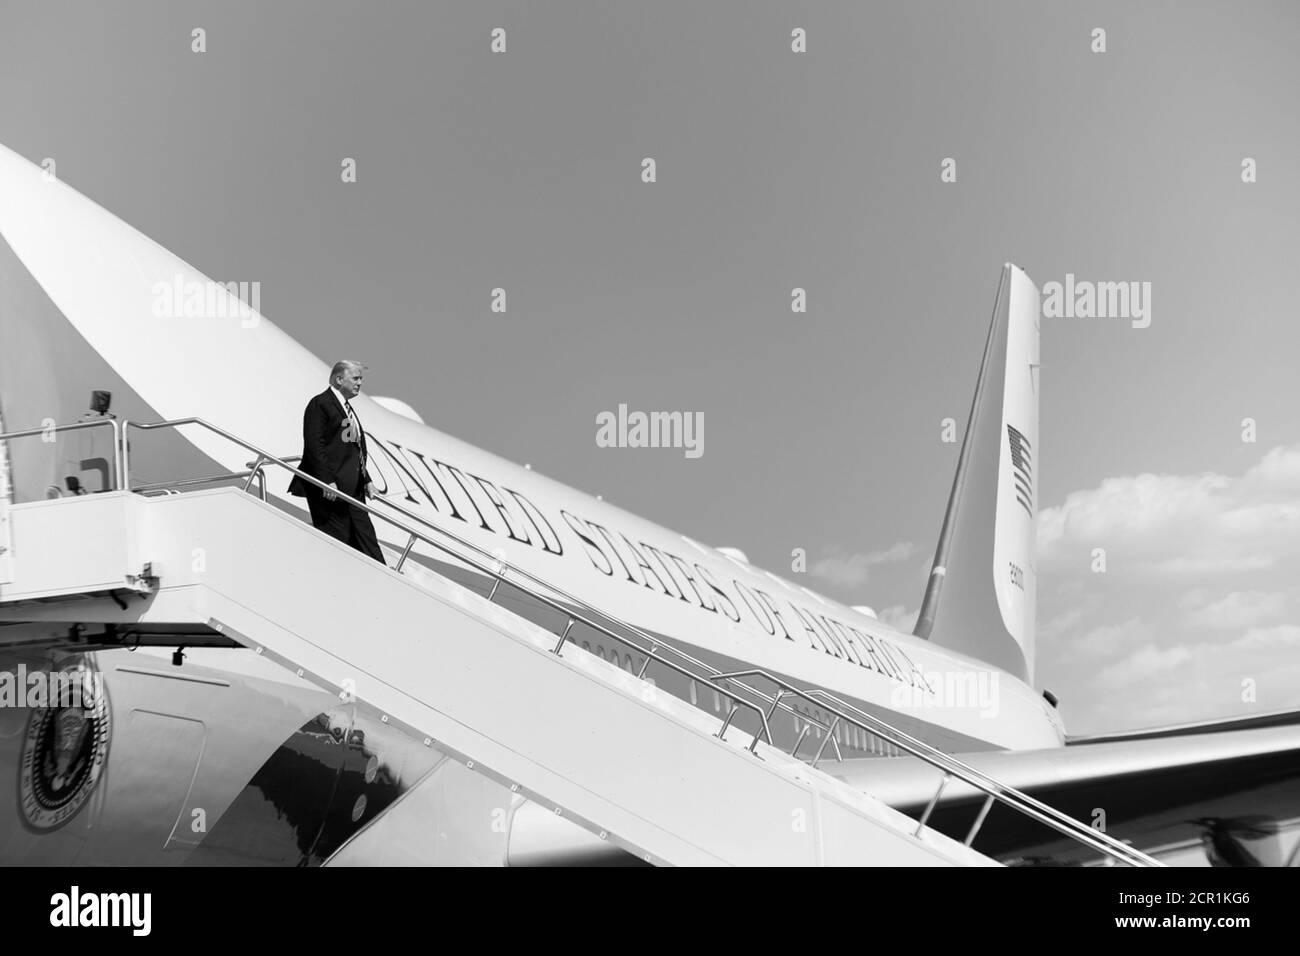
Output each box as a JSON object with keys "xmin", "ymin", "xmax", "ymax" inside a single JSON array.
[{"xmin": 18, "ymin": 662, "xmax": 111, "ymax": 831}]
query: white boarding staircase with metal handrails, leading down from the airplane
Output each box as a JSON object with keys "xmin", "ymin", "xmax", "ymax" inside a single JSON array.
[{"xmin": 0, "ymin": 419, "xmax": 1154, "ymax": 866}]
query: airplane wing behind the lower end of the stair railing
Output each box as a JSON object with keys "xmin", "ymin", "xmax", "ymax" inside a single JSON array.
[{"xmin": 831, "ymin": 711, "xmax": 1300, "ymax": 866}]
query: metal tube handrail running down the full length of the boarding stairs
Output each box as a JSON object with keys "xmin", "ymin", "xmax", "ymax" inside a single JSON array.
[{"xmin": 15, "ymin": 418, "xmax": 1164, "ymax": 866}]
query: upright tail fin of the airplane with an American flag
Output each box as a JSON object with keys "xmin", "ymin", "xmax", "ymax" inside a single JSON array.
[{"xmin": 914, "ymin": 263, "xmax": 1040, "ymax": 682}]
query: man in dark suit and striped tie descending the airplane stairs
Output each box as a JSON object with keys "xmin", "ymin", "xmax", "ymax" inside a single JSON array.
[{"xmin": 289, "ymin": 359, "xmax": 387, "ymax": 564}]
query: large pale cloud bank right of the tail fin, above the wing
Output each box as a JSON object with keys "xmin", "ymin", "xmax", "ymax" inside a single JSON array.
[{"xmin": 1036, "ymin": 445, "xmax": 1300, "ymax": 734}]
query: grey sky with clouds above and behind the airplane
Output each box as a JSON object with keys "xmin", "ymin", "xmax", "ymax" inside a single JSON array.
[{"xmin": 0, "ymin": 0, "xmax": 1300, "ymax": 734}]
